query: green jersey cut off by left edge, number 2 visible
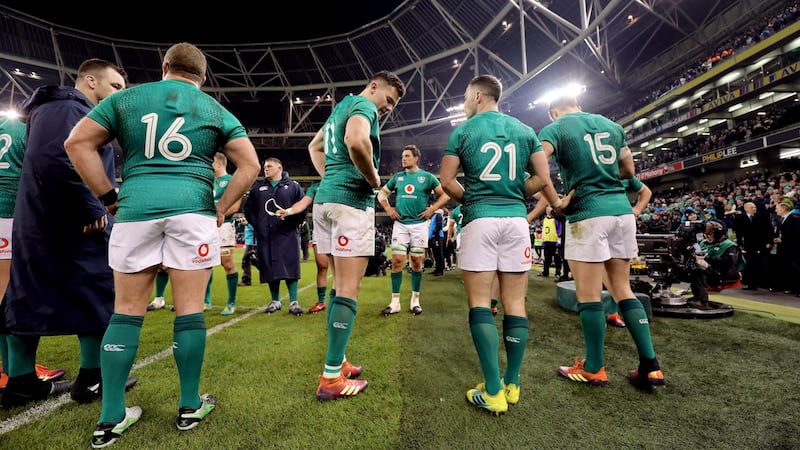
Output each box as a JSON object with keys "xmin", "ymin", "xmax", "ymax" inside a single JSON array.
[{"xmin": 0, "ymin": 117, "xmax": 26, "ymax": 219}]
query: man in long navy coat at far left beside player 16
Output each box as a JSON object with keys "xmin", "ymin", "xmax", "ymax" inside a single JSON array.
[{"xmin": 2, "ymin": 59, "xmax": 134, "ymax": 408}]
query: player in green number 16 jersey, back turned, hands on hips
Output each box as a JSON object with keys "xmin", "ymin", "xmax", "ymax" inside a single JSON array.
[{"xmin": 65, "ymin": 42, "xmax": 260, "ymax": 448}]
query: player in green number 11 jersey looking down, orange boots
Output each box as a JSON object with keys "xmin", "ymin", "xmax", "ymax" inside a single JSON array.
[{"xmin": 308, "ymin": 71, "xmax": 405, "ymax": 401}]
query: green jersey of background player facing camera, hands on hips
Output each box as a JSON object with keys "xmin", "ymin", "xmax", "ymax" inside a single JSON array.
[{"xmin": 386, "ymin": 169, "xmax": 440, "ymax": 225}]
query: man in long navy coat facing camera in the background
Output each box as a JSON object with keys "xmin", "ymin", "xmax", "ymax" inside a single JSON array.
[{"xmin": 244, "ymin": 158, "xmax": 305, "ymax": 316}]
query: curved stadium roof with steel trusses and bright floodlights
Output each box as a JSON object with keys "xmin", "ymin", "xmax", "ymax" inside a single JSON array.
[{"xmin": 0, "ymin": 0, "xmax": 785, "ymax": 148}]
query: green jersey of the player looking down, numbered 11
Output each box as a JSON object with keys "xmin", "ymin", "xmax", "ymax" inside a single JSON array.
[{"xmin": 314, "ymin": 95, "xmax": 381, "ymax": 210}]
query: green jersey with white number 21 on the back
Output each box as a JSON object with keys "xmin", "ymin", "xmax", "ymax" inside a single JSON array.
[{"xmin": 445, "ymin": 111, "xmax": 542, "ymax": 226}]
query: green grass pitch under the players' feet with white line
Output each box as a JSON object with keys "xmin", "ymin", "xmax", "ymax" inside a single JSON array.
[{"xmin": 0, "ymin": 250, "xmax": 800, "ymax": 449}]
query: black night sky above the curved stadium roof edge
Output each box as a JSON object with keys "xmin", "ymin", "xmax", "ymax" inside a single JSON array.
[{"xmin": 3, "ymin": 0, "xmax": 402, "ymax": 44}]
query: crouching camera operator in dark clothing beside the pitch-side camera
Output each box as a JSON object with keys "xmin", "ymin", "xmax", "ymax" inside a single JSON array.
[{"xmin": 687, "ymin": 220, "xmax": 744, "ymax": 309}]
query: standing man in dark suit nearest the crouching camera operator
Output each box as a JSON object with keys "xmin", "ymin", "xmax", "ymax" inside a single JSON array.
[{"xmin": 733, "ymin": 202, "xmax": 774, "ymax": 290}]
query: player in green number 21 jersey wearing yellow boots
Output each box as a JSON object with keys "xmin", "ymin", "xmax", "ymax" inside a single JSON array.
[{"xmin": 440, "ymin": 75, "xmax": 558, "ymax": 414}]
